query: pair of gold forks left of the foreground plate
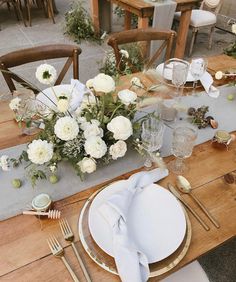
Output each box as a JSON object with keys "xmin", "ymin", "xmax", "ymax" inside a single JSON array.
[{"xmin": 47, "ymin": 218, "xmax": 92, "ymax": 282}]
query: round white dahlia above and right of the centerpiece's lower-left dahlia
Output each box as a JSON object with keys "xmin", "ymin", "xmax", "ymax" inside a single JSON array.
[{"xmin": 54, "ymin": 117, "xmax": 79, "ymax": 141}]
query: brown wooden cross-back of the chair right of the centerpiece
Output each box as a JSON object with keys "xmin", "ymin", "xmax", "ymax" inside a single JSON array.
[{"xmin": 107, "ymin": 28, "xmax": 176, "ymax": 72}]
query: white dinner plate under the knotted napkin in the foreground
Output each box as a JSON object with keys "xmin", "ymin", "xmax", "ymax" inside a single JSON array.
[{"xmin": 88, "ymin": 180, "xmax": 186, "ymax": 263}]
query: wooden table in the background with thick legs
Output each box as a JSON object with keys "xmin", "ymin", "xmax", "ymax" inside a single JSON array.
[{"xmin": 90, "ymin": 0, "xmax": 200, "ymax": 59}]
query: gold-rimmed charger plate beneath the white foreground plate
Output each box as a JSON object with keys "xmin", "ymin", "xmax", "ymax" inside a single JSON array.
[{"xmin": 78, "ymin": 186, "xmax": 192, "ymax": 277}]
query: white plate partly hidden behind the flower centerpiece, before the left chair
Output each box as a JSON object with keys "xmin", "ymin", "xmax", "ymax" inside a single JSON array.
[{"xmin": 37, "ymin": 84, "xmax": 77, "ymax": 110}]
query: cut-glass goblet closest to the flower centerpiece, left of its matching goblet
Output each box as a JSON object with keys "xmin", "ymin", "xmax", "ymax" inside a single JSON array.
[{"xmin": 141, "ymin": 117, "xmax": 165, "ymax": 167}]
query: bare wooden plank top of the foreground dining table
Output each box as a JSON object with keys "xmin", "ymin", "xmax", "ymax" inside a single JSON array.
[{"xmin": 0, "ymin": 55, "xmax": 236, "ymax": 282}]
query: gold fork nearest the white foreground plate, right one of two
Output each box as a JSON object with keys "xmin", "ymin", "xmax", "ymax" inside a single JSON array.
[{"xmin": 59, "ymin": 218, "xmax": 92, "ymax": 282}]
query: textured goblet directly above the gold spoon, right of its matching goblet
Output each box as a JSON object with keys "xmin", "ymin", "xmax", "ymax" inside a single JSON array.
[{"xmin": 169, "ymin": 125, "xmax": 197, "ymax": 174}]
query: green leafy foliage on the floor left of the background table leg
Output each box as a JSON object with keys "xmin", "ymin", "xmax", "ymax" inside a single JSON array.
[{"xmin": 65, "ymin": 1, "xmax": 101, "ymax": 43}]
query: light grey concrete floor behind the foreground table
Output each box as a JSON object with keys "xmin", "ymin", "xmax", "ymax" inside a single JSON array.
[{"xmin": 0, "ymin": 0, "xmax": 233, "ymax": 98}]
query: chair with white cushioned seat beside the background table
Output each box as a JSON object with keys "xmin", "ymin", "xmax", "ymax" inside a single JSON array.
[{"xmin": 174, "ymin": 0, "xmax": 223, "ymax": 56}]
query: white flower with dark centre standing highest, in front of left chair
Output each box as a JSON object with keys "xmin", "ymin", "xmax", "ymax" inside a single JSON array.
[{"xmin": 35, "ymin": 64, "xmax": 57, "ymax": 85}]
